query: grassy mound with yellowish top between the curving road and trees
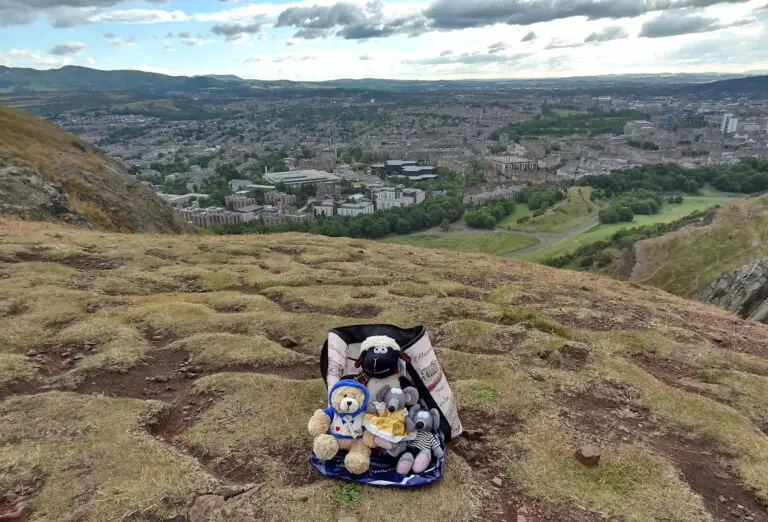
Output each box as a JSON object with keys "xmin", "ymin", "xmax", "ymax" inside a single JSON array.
[{"xmin": 499, "ymin": 187, "xmax": 598, "ymax": 234}]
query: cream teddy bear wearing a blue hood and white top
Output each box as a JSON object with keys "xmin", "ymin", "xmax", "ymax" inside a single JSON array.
[{"xmin": 308, "ymin": 379, "xmax": 371, "ymax": 475}]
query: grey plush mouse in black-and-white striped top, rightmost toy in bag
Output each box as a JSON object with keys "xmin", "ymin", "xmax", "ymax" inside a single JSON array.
[{"xmin": 397, "ymin": 404, "xmax": 445, "ymax": 475}]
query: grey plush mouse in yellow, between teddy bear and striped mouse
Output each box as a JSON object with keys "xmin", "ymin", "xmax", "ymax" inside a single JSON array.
[{"xmin": 363, "ymin": 386, "xmax": 419, "ymax": 457}]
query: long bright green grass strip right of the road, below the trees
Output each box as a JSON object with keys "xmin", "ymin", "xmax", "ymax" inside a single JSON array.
[{"xmin": 521, "ymin": 196, "xmax": 729, "ymax": 262}]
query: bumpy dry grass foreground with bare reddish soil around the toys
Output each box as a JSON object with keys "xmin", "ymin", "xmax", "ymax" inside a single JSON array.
[{"xmin": 0, "ymin": 220, "xmax": 768, "ymax": 522}]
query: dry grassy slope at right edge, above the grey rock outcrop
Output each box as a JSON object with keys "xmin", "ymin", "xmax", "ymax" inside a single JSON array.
[{"xmin": 630, "ymin": 196, "xmax": 768, "ymax": 296}]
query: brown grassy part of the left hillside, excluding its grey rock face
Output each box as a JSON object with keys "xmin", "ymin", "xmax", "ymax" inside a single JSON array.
[{"xmin": 0, "ymin": 107, "xmax": 184, "ymax": 232}]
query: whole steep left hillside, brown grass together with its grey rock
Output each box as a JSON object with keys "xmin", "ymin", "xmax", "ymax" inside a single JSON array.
[{"xmin": 0, "ymin": 106, "xmax": 185, "ymax": 232}]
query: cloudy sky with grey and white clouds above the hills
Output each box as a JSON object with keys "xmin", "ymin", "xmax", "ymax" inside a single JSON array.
[{"xmin": 0, "ymin": 0, "xmax": 768, "ymax": 80}]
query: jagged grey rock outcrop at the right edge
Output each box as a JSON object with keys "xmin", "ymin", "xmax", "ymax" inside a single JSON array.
[{"xmin": 700, "ymin": 257, "xmax": 768, "ymax": 323}]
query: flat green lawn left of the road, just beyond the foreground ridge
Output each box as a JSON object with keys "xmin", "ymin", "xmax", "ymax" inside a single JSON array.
[{"xmin": 386, "ymin": 232, "xmax": 539, "ymax": 255}]
